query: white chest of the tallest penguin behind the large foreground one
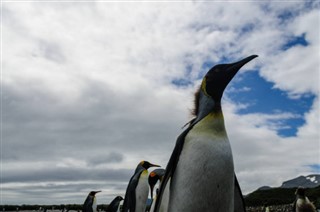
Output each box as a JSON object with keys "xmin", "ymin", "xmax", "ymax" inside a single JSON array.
[{"xmin": 135, "ymin": 170, "xmax": 149, "ymax": 212}]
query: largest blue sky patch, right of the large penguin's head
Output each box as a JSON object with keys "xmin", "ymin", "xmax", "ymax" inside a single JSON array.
[{"xmin": 229, "ymin": 71, "xmax": 315, "ymax": 137}]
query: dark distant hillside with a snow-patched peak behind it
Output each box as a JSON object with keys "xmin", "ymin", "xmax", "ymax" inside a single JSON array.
[{"xmin": 245, "ymin": 175, "xmax": 320, "ymax": 208}]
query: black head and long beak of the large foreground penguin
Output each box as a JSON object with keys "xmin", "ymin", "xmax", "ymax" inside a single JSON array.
[{"xmin": 193, "ymin": 55, "xmax": 258, "ymax": 116}]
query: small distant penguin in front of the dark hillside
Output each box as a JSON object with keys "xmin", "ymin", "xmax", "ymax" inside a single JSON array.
[{"xmin": 293, "ymin": 187, "xmax": 316, "ymax": 212}]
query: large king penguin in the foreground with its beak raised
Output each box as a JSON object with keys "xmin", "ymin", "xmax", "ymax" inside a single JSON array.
[{"xmin": 155, "ymin": 55, "xmax": 257, "ymax": 212}]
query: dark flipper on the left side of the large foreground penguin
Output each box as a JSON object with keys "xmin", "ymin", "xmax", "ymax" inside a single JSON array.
[{"xmin": 154, "ymin": 124, "xmax": 195, "ymax": 212}]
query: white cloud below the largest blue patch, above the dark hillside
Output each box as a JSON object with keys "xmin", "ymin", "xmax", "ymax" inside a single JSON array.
[{"xmin": 224, "ymin": 97, "xmax": 319, "ymax": 193}]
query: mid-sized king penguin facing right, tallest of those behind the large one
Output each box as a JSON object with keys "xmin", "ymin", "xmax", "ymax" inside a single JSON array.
[{"xmin": 123, "ymin": 161, "xmax": 160, "ymax": 212}]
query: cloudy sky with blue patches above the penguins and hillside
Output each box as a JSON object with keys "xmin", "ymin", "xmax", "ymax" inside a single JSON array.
[{"xmin": 0, "ymin": 0, "xmax": 320, "ymax": 205}]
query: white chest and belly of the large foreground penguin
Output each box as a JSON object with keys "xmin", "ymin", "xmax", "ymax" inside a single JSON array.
[{"xmin": 169, "ymin": 116, "xmax": 234, "ymax": 212}]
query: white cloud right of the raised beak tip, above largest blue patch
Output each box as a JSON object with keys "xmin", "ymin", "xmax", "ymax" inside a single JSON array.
[{"xmin": 261, "ymin": 6, "xmax": 320, "ymax": 97}]
